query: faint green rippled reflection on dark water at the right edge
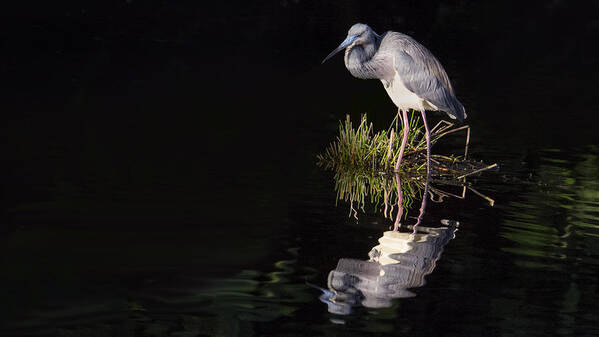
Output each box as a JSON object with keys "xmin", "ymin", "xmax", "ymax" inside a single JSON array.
[{"xmin": 501, "ymin": 147, "xmax": 599, "ymax": 269}]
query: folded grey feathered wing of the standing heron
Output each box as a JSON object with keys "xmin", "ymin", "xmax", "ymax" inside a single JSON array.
[{"xmin": 379, "ymin": 32, "xmax": 467, "ymax": 121}]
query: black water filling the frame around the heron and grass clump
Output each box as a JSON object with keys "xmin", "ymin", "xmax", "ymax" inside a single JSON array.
[{"xmin": 0, "ymin": 1, "xmax": 599, "ymax": 336}]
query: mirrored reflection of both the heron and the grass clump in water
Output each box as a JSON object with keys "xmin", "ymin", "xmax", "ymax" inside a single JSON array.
[{"xmin": 310, "ymin": 135, "xmax": 496, "ymax": 315}]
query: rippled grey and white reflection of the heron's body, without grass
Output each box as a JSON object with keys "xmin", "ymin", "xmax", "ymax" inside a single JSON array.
[{"xmin": 319, "ymin": 220, "xmax": 459, "ymax": 315}]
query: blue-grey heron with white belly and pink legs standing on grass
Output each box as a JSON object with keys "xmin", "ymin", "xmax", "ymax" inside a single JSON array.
[{"xmin": 322, "ymin": 23, "xmax": 466, "ymax": 175}]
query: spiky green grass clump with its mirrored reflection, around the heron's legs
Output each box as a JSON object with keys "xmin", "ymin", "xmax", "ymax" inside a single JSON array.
[{"xmin": 317, "ymin": 113, "xmax": 495, "ymax": 218}]
